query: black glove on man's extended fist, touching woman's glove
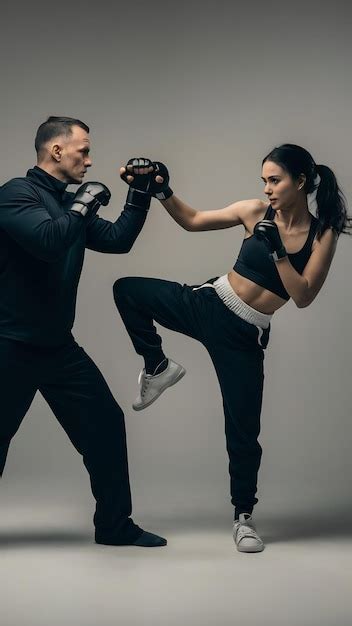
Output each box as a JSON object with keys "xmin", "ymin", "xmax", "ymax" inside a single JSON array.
[{"xmin": 120, "ymin": 157, "xmax": 153, "ymax": 211}]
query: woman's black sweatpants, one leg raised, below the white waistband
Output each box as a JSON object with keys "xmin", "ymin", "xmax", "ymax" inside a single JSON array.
[{"xmin": 114, "ymin": 277, "xmax": 270, "ymax": 513}]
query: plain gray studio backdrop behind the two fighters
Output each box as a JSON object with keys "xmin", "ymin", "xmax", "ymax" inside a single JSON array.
[{"xmin": 0, "ymin": 1, "xmax": 352, "ymax": 530}]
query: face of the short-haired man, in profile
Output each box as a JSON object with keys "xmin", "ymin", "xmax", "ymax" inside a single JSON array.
[{"xmin": 58, "ymin": 126, "xmax": 92, "ymax": 184}]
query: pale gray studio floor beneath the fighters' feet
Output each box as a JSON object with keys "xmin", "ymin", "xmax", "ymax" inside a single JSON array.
[{"xmin": 0, "ymin": 500, "xmax": 352, "ymax": 626}]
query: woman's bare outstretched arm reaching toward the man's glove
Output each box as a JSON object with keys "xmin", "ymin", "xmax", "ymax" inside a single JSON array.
[{"xmin": 160, "ymin": 195, "xmax": 267, "ymax": 231}]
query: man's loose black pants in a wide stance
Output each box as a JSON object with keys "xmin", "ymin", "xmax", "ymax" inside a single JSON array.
[{"xmin": 0, "ymin": 337, "xmax": 142, "ymax": 544}]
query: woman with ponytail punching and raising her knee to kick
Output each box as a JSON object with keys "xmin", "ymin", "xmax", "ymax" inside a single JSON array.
[{"xmin": 114, "ymin": 144, "xmax": 350, "ymax": 552}]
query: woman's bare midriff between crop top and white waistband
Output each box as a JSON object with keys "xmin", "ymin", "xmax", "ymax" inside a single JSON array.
[{"xmin": 228, "ymin": 270, "xmax": 287, "ymax": 315}]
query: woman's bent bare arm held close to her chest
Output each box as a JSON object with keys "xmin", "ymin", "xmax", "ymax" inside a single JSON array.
[{"xmin": 276, "ymin": 228, "xmax": 338, "ymax": 309}]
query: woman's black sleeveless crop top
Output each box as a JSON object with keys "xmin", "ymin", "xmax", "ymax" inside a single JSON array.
[{"xmin": 233, "ymin": 205, "xmax": 318, "ymax": 300}]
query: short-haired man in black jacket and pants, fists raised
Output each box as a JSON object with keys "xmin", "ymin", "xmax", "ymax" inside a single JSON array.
[{"xmin": 0, "ymin": 117, "xmax": 166, "ymax": 546}]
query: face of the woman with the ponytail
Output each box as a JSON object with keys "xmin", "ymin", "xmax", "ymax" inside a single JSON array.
[{"xmin": 262, "ymin": 161, "xmax": 305, "ymax": 210}]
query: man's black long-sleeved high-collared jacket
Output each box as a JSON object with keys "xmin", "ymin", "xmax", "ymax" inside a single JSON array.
[{"xmin": 0, "ymin": 166, "xmax": 147, "ymax": 346}]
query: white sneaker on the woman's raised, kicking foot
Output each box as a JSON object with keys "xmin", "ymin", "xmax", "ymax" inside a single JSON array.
[{"xmin": 132, "ymin": 359, "xmax": 186, "ymax": 411}]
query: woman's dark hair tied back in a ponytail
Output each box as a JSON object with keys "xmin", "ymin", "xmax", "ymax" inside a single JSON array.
[{"xmin": 262, "ymin": 143, "xmax": 352, "ymax": 238}]
